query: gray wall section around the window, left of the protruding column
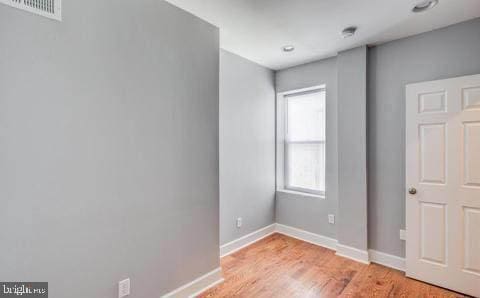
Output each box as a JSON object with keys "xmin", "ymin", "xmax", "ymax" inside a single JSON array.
[{"xmin": 276, "ymin": 58, "xmax": 338, "ymax": 238}]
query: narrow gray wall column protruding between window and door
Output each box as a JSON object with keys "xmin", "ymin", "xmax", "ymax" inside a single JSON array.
[{"xmin": 337, "ymin": 46, "xmax": 368, "ymax": 250}]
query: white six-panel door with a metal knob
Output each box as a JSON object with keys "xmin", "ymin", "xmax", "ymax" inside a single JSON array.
[{"xmin": 406, "ymin": 75, "xmax": 480, "ymax": 297}]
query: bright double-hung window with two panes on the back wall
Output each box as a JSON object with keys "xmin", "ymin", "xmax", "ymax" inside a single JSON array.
[{"xmin": 284, "ymin": 89, "xmax": 326, "ymax": 195}]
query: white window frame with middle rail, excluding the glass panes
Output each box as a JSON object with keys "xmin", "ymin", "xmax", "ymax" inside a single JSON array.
[{"xmin": 277, "ymin": 85, "xmax": 327, "ymax": 198}]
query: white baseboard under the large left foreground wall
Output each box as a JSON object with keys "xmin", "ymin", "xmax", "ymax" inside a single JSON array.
[{"xmin": 161, "ymin": 268, "xmax": 224, "ymax": 298}]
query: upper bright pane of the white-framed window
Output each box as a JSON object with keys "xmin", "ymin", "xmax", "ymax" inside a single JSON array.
[{"xmin": 287, "ymin": 91, "xmax": 325, "ymax": 141}]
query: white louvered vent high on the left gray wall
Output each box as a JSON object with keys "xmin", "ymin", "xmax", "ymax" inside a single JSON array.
[{"xmin": 0, "ymin": 0, "xmax": 62, "ymax": 21}]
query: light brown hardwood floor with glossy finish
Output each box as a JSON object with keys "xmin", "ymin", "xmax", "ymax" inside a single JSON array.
[{"xmin": 200, "ymin": 234, "xmax": 465, "ymax": 298}]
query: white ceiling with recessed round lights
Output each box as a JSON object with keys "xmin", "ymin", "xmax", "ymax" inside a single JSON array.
[{"xmin": 167, "ymin": 0, "xmax": 480, "ymax": 70}]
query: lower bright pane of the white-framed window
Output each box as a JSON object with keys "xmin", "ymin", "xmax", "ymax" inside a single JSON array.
[{"xmin": 286, "ymin": 144, "xmax": 325, "ymax": 191}]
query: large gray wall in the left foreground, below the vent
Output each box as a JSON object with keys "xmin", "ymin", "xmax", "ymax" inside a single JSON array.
[{"xmin": 0, "ymin": 0, "xmax": 220, "ymax": 298}]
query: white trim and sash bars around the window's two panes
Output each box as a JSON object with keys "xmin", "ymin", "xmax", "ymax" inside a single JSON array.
[{"xmin": 281, "ymin": 85, "xmax": 327, "ymax": 197}]
